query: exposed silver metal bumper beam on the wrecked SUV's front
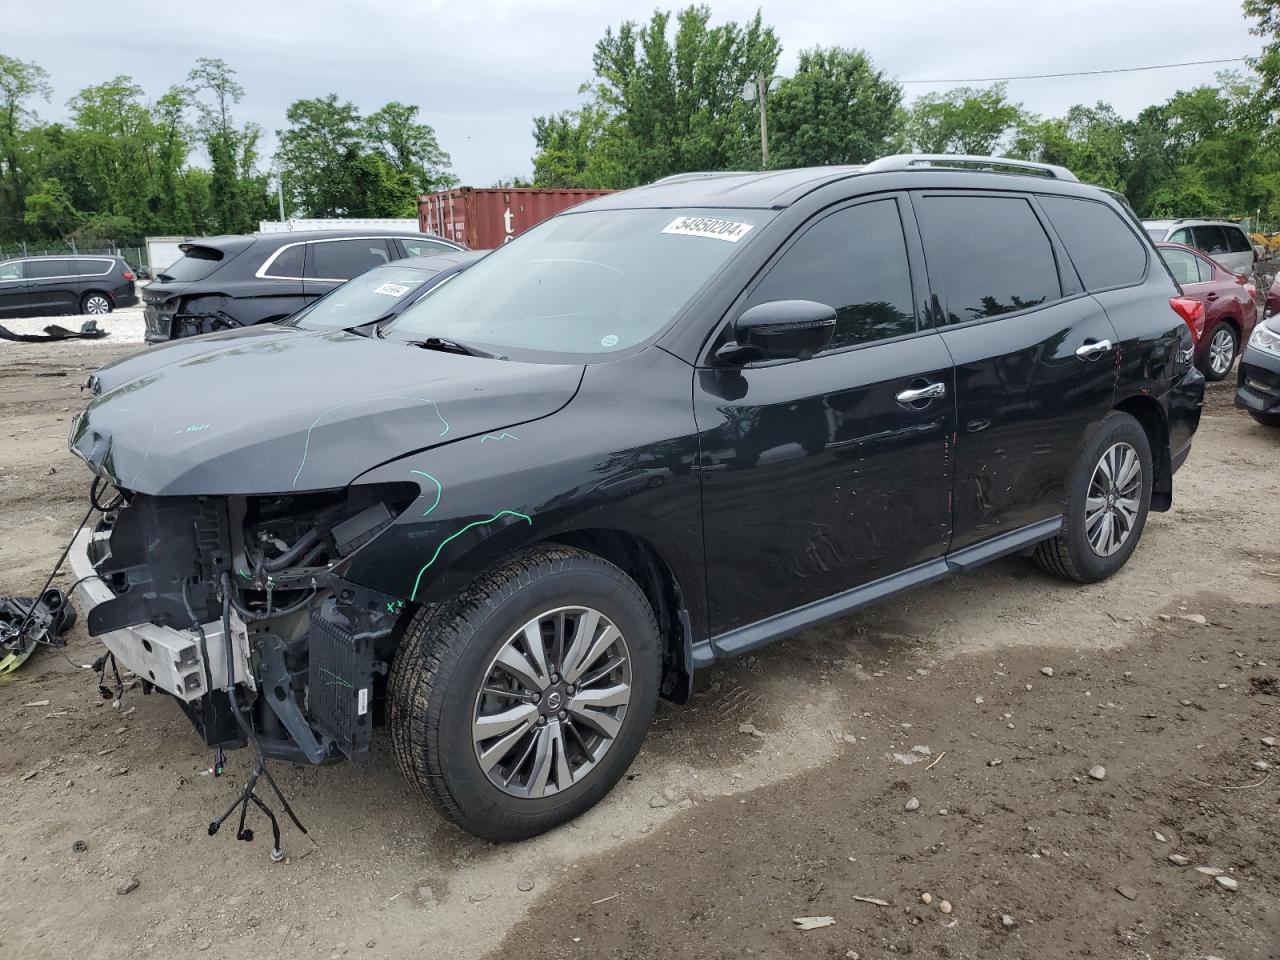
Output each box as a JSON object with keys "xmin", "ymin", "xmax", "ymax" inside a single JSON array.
[{"xmin": 67, "ymin": 530, "xmax": 252, "ymax": 703}]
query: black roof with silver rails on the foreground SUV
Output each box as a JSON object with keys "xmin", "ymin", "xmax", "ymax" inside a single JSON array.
[{"xmin": 575, "ymin": 154, "xmax": 1079, "ymax": 211}]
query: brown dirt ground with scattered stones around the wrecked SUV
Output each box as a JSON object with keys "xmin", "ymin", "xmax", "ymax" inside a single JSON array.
[{"xmin": 0, "ymin": 344, "xmax": 1280, "ymax": 960}]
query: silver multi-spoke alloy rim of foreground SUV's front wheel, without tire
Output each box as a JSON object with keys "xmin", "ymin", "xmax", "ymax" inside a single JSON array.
[{"xmin": 471, "ymin": 607, "xmax": 631, "ymax": 799}]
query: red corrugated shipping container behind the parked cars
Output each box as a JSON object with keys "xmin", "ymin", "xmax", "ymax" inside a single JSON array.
[{"xmin": 417, "ymin": 187, "xmax": 613, "ymax": 250}]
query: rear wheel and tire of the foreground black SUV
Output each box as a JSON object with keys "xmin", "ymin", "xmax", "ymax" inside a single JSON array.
[{"xmin": 1036, "ymin": 411, "xmax": 1152, "ymax": 584}]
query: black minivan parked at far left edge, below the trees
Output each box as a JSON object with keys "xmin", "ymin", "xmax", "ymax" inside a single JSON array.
[{"xmin": 0, "ymin": 253, "xmax": 138, "ymax": 316}]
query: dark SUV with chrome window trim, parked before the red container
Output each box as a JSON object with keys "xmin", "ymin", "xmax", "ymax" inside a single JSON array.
[{"xmin": 142, "ymin": 229, "xmax": 462, "ymax": 343}]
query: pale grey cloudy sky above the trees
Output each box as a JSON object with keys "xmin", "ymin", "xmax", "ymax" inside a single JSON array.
[{"xmin": 0, "ymin": 0, "xmax": 1260, "ymax": 186}]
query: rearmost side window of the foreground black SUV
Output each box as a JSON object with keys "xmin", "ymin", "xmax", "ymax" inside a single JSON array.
[{"xmin": 1039, "ymin": 196, "xmax": 1147, "ymax": 291}]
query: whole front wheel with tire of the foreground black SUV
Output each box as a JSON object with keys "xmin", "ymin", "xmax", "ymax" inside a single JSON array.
[{"xmin": 388, "ymin": 545, "xmax": 662, "ymax": 841}]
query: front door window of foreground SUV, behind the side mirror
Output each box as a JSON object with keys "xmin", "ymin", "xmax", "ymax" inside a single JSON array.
[{"xmin": 748, "ymin": 200, "xmax": 915, "ymax": 348}]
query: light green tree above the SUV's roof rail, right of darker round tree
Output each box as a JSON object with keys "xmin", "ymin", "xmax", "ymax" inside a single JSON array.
[{"xmin": 906, "ymin": 83, "xmax": 1027, "ymax": 156}]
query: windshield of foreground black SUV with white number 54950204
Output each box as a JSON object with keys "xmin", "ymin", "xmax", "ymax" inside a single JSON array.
[{"xmin": 384, "ymin": 210, "xmax": 772, "ymax": 353}]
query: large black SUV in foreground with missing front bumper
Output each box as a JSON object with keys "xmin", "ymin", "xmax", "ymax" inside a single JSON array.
[{"xmin": 70, "ymin": 156, "xmax": 1204, "ymax": 840}]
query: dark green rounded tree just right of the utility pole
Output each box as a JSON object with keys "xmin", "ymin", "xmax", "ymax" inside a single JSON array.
[{"xmin": 768, "ymin": 46, "xmax": 902, "ymax": 166}]
